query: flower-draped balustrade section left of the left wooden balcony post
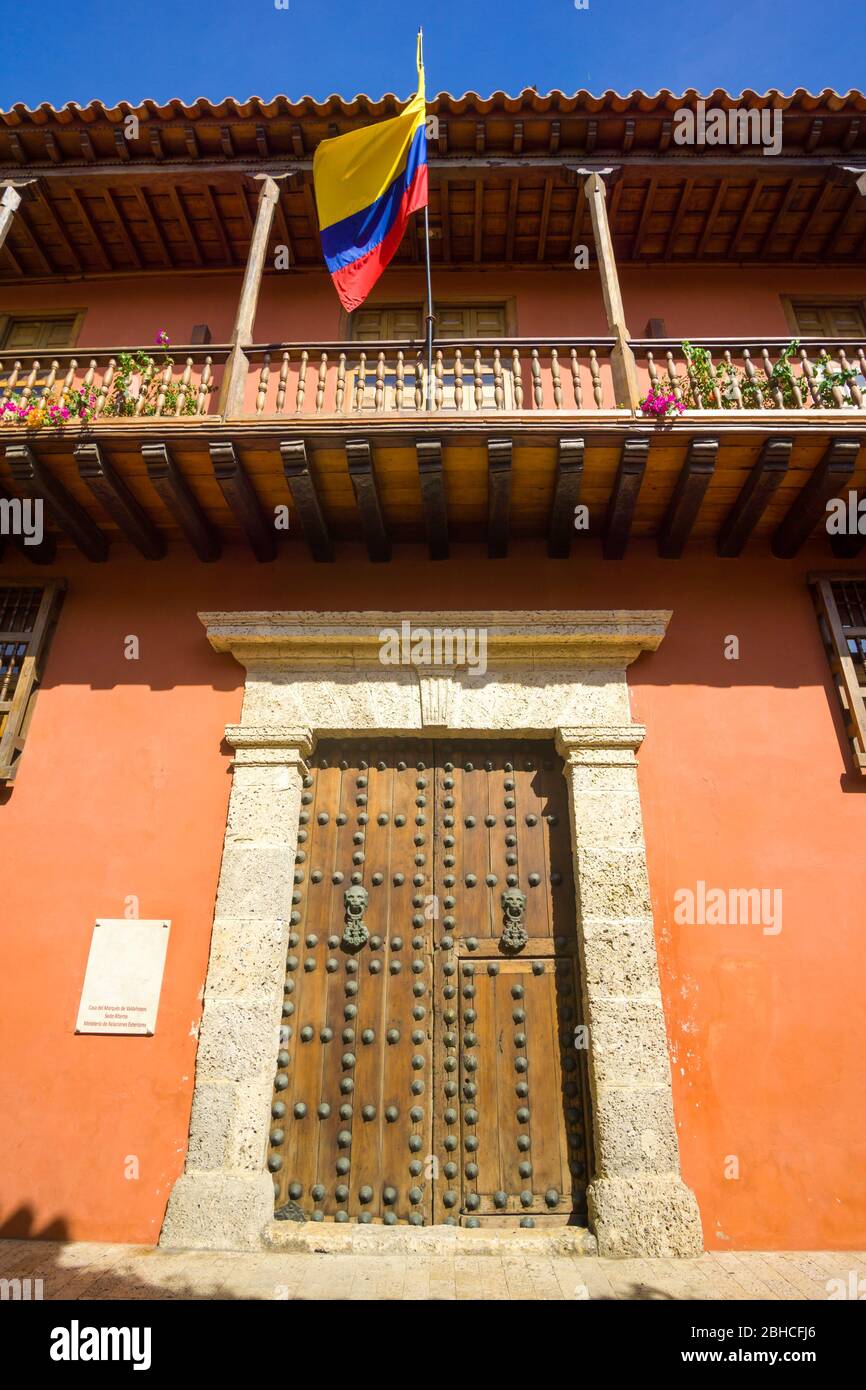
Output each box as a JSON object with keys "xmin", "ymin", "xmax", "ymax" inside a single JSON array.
[{"xmin": 0, "ymin": 345, "xmax": 229, "ymax": 423}]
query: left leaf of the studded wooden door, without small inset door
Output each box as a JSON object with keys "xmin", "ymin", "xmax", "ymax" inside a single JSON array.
[{"xmin": 270, "ymin": 741, "xmax": 432, "ymax": 1225}]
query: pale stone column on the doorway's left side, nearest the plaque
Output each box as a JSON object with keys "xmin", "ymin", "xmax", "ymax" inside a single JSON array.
[{"xmin": 160, "ymin": 724, "xmax": 314, "ymax": 1250}]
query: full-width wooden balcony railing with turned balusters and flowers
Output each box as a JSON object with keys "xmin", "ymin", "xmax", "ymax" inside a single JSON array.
[{"xmin": 0, "ymin": 338, "xmax": 866, "ymax": 430}]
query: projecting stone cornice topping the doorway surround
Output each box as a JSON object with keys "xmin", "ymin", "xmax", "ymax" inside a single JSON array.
[{"xmin": 199, "ymin": 609, "xmax": 671, "ymax": 673}]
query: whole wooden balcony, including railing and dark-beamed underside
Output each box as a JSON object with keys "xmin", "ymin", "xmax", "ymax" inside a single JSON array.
[{"xmin": 0, "ymin": 338, "xmax": 866, "ymax": 560}]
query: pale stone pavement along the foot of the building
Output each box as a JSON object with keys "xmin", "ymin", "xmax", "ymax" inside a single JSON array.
[{"xmin": 0, "ymin": 1238, "xmax": 866, "ymax": 1301}]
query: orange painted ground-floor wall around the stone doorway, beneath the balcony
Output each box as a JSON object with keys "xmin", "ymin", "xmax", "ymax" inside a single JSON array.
[{"xmin": 0, "ymin": 543, "xmax": 866, "ymax": 1250}]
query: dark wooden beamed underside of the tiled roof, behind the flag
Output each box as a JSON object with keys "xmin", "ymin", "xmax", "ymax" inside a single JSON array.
[{"xmin": 0, "ymin": 92, "xmax": 866, "ymax": 282}]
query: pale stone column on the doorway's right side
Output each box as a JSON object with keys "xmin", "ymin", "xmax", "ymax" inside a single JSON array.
[{"xmin": 556, "ymin": 724, "xmax": 703, "ymax": 1257}]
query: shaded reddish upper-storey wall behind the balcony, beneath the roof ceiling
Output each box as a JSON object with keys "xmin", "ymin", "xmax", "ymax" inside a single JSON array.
[{"xmin": 0, "ymin": 265, "xmax": 866, "ymax": 348}]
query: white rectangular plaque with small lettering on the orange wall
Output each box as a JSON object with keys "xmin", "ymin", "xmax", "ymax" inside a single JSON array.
[{"xmin": 75, "ymin": 917, "xmax": 171, "ymax": 1036}]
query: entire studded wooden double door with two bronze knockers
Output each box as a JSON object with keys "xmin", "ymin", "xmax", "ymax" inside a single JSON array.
[{"xmin": 268, "ymin": 739, "xmax": 589, "ymax": 1226}]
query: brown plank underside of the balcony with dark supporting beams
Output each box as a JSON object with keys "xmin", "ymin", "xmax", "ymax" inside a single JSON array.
[{"xmin": 0, "ymin": 421, "xmax": 866, "ymax": 564}]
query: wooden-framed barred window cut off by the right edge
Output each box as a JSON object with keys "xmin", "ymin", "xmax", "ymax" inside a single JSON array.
[{"xmin": 810, "ymin": 574, "xmax": 866, "ymax": 776}]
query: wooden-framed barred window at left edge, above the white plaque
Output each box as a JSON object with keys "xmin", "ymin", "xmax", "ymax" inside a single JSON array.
[{"xmin": 0, "ymin": 580, "xmax": 64, "ymax": 783}]
